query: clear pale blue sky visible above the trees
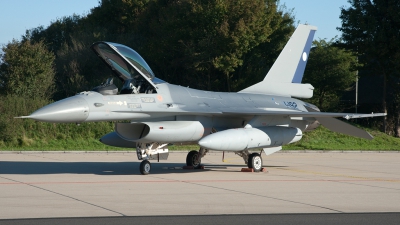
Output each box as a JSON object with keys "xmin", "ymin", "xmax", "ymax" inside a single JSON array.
[{"xmin": 0, "ymin": 0, "xmax": 349, "ymax": 46}]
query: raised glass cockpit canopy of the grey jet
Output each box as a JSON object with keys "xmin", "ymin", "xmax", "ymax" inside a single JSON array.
[{"xmin": 91, "ymin": 41, "xmax": 165, "ymax": 94}]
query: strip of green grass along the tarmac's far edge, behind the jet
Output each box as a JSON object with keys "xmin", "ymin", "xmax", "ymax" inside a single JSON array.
[{"xmin": 0, "ymin": 127, "xmax": 400, "ymax": 151}]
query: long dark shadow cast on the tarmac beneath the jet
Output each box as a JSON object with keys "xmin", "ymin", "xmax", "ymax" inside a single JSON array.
[{"xmin": 0, "ymin": 161, "xmax": 288, "ymax": 175}]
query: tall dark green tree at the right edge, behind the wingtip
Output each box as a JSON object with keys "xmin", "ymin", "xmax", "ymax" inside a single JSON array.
[{"xmin": 338, "ymin": 0, "xmax": 400, "ymax": 137}]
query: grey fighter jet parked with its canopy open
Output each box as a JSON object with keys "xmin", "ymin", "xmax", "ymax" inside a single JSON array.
[{"xmin": 19, "ymin": 25, "xmax": 386, "ymax": 174}]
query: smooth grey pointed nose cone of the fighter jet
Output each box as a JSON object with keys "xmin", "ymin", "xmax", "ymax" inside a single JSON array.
[{"xmin": 25, "ymin": 96, "xmax": 89, "ymax": 123}]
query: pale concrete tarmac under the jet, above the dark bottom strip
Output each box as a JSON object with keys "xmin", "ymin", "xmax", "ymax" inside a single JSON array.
[{"xmin": 0, "ymin": 152, "xmax": 400, "ymax": 219}]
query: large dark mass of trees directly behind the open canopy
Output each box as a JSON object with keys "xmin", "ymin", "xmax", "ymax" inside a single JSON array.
[{"xmin": 23, "ymin": 0, "xmax": 294, "ymax": 96}]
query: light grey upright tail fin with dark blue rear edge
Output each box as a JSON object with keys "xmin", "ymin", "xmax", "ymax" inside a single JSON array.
[{"xmin": 240, "ymin": 24, "xmax": 317, "ymax": 98}]
